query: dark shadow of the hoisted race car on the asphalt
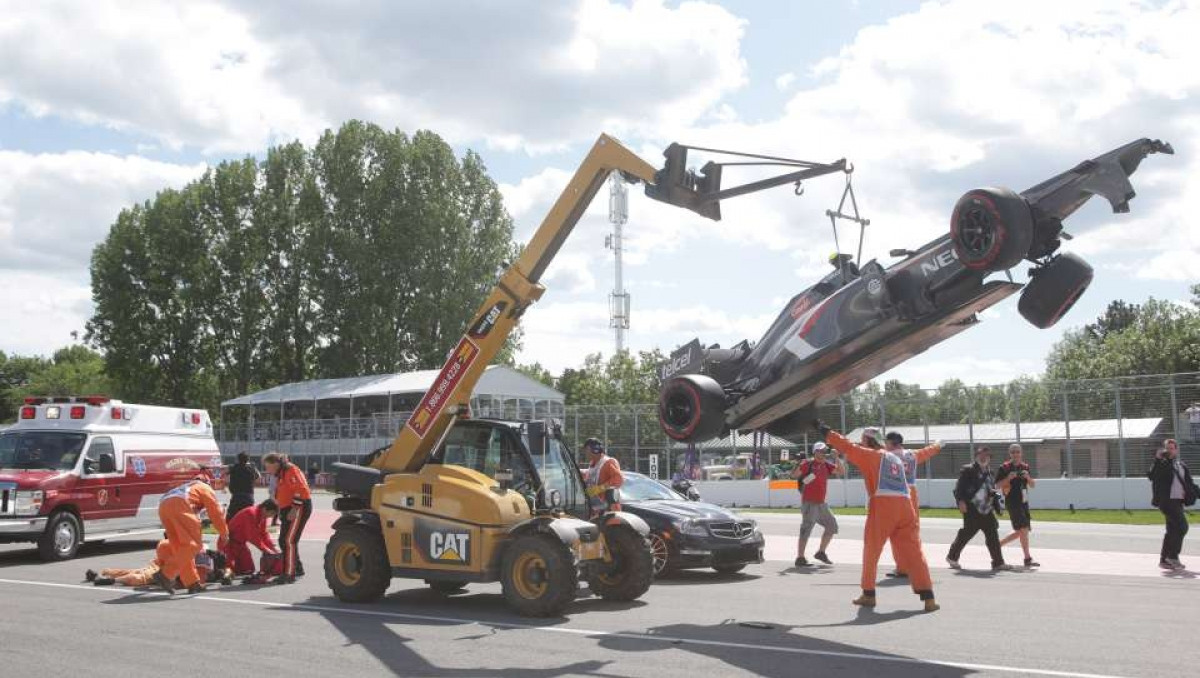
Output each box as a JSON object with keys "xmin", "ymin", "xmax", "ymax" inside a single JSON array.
[{"xmin": 600, "ymin": 613, "xmax": 973, "ymax": 678}]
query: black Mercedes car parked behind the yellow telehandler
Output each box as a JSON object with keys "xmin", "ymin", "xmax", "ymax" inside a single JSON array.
[{"xmin": 620, "ymin": 472, "xmax": 764, "ymax": 576}]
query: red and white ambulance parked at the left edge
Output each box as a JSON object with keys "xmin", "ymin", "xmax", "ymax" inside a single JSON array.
[{"xmin": 0, "ymin": 396, "xmax": 221, "ymax": 560}]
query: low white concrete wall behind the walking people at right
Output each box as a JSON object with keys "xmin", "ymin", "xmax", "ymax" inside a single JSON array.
[{"xmin": 696, "ymin": 478, "xmax": 1152, "ymax": 509}]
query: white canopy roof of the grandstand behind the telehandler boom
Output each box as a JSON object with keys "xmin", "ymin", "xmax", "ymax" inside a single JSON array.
[{"xmin": 221, "ymin": 365, "xmax": 564, "ymax": 408}]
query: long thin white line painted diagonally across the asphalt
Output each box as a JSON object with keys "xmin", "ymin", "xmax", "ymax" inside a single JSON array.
[{"xmin": 0, "ymin": 578, "xmax": 1126, "ymax": 678}]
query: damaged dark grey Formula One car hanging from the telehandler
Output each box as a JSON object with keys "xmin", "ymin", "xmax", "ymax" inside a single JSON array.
[{"xmin": 659, "ymin": 139, "xmax": 1174, "ymax": 443}]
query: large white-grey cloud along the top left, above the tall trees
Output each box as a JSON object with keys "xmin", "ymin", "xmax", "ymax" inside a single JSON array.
[{"xmin": 0, "ymin": 0, "xmax": 746, "ymax": 152}]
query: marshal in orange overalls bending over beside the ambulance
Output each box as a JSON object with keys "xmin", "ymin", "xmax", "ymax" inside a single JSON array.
[{"xmin": 158, "ymin": 480, "xmax": 229, "ymax": 588}]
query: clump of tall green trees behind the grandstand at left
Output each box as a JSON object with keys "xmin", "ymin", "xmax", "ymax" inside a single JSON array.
[{"xmin": 88, "ymin": 121, "xmax": 516, "ymax": 407}]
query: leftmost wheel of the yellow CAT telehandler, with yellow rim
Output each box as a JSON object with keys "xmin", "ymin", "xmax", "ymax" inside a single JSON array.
[{"xmin": 325, "ymin": 524, "xmax": 391, "ymax": 602}]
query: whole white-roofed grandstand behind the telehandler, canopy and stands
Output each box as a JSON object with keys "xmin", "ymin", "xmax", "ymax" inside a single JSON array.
[{"xmin": 217, "ymin": 365, "xmax": 565, "ymax": 467}]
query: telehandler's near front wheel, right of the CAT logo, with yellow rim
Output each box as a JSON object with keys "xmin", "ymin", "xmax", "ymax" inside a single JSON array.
[{"xmin": 500, "ymin": 534, "xmax": 580, "ymax": 617}]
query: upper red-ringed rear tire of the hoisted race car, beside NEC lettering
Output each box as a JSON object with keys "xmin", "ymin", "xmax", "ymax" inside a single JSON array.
[{"xmin": 950, "ymin": 188, "xmax": 1033, "ymax": 271}]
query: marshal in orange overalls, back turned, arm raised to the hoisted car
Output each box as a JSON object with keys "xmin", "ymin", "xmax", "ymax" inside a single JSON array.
[{"xmin": 814, "ymin": 420, "xmax": 940, "ymax": 612}]
